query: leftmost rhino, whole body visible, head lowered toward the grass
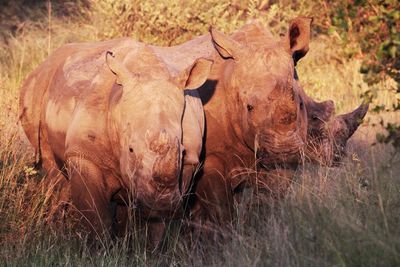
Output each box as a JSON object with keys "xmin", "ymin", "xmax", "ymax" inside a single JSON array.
[{"xmin": 20, "ymin": 39, "xmax": 212, "ymax": 242}]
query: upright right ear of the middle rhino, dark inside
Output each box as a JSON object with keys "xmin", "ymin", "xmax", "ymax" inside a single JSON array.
[{"xmin": 284, "ymin": 17, "xmax": 313, "ymax": 65}]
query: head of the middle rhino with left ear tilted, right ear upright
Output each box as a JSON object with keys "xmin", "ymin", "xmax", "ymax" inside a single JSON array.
[{"xmin": 210, "ymin": 20, "xmax": 311, "ymax": 169}]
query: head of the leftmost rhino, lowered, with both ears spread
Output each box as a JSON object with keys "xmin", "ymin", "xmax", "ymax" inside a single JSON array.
[{"xmin": 106, "ymin": 52, "xmax": 212, "ymax": 216}]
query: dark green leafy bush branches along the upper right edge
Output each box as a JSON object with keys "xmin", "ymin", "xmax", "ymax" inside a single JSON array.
[{"xmin": 318, "ymin": 0, "xmax": 400, "ymax": 152}]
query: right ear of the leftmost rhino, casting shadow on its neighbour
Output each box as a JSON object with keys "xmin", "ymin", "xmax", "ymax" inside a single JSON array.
[{"xmin": 177, "ymin": 58, "xmax": 213, "ymax": 89}]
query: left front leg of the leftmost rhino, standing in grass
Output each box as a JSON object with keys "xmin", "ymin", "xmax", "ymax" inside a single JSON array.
[{"xmin": 68, "ymin": 157, "xmax": 112, "ymax": 243}]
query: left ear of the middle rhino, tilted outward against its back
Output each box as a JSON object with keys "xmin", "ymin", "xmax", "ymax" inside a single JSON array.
[{"xmin": 209, "ymin": 27, "xmax": 242, "ymax": 59}]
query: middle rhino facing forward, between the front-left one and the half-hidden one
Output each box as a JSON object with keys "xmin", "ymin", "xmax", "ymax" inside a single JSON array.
[{"xmin": 150, "ymin": 19, "xmax": 310, "ymax": 224}]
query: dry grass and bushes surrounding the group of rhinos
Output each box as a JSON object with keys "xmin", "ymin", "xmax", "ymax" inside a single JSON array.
[{"xmin": 0, "ymin": 0, "xmax": 400, "ymax": 266}]
